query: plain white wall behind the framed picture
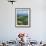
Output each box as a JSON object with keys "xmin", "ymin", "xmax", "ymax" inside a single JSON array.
[{"xmin": 0, "ymin": 0, "xmax": 46, "ymax": 41}]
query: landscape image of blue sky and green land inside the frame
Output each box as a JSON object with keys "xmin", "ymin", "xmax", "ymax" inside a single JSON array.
[{"xmin": 17, "ymin": 9, "xmax": 28, "ymax": 25}]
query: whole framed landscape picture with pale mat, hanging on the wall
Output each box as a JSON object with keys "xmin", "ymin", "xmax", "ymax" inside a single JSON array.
[{"xmin": 15, "ymin": 8, "xmax": 31, "ymax": 27}]
